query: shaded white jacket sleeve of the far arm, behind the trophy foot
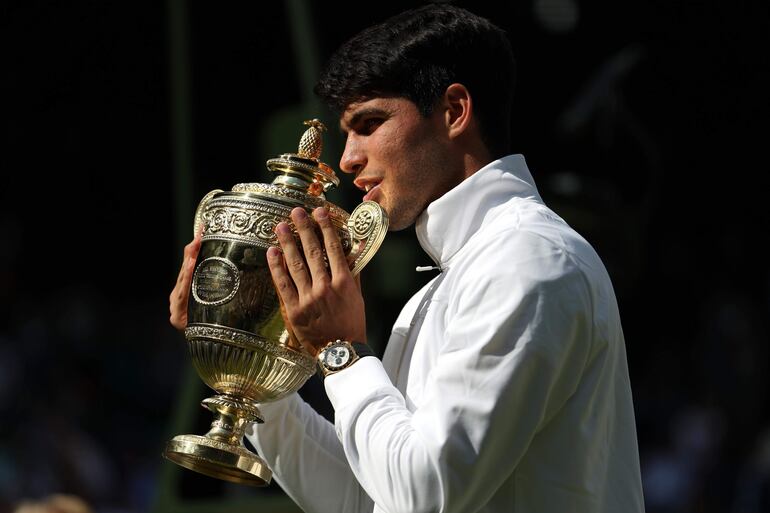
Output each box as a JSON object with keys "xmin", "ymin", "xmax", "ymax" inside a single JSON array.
[{"xmin": 247, "ymin": 394, "xmax": 374, "ymax": 513}]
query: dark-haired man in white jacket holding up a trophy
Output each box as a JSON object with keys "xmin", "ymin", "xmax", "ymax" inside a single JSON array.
[{"xmin": 171, "ymin": 4, "xmax": 643, "ymax": 513}]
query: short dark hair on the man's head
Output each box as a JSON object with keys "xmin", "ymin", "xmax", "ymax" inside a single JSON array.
[{"xmin": 314, "ymin": 4, "xmax": 515, "ymax": 157}]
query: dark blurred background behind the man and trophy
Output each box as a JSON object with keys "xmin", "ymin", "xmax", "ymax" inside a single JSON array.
[{"xmin": 0, "ymin": 0, "xmax": 770, "ymax": 513}]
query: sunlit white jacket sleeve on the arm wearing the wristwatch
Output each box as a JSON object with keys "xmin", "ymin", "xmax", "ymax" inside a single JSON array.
[{"xmin": 325, "ymin": 241, "xmax": 591, "ymax": 513}]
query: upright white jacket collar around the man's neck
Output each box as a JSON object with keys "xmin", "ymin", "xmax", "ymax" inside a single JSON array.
[{"xmin": 415, "ymin": 155, "xmax": 542, "ymax": 269}]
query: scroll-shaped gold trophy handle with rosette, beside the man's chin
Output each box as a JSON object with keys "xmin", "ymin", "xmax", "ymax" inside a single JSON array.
[{"xmin": 348, "ymin": 200, "xmax": 388, "ymax": 276}]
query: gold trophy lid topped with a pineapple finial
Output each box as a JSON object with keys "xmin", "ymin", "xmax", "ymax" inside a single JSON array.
[{"xmin": 267, "ymin": 119, "xmax": 340, "ymax": 196}]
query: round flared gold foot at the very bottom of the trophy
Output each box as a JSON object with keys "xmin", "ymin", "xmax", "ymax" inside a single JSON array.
[{"xmin": 163, "ymin": 435, "xmax": 273, "ymax": 486}]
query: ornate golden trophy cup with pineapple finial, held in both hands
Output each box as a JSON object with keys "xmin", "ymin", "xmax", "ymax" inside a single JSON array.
[{"xmin": 163, "ymin": 120, "xmax": 388, "ymax": 486}]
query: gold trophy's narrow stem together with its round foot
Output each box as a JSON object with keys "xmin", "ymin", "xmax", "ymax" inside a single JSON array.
[{"xmin": 163, "ymin": 395, "xmax": 273, "ymax": 486}]
